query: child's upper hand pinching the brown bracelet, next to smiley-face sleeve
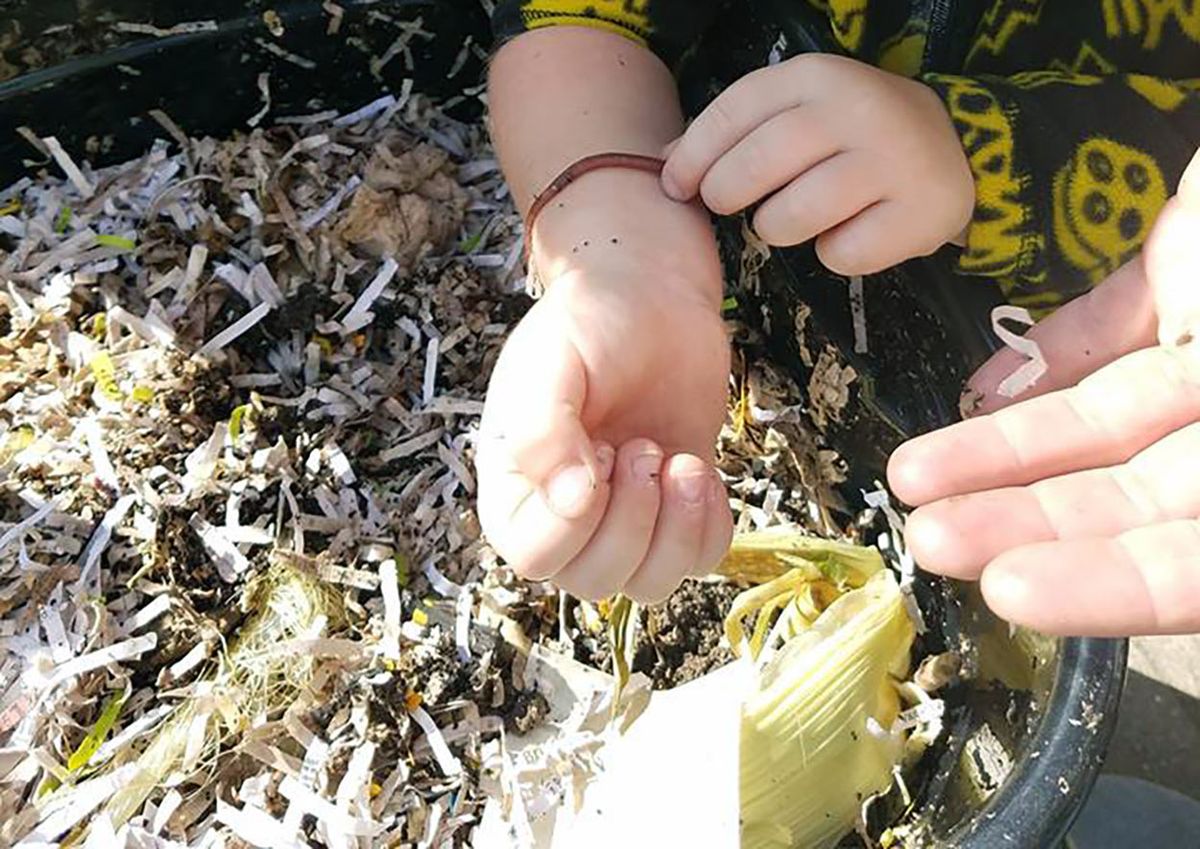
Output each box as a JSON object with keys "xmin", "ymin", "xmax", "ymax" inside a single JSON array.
[{"xmin": 662, "ymin": 54, "xmax": 976, "ymax": 275}]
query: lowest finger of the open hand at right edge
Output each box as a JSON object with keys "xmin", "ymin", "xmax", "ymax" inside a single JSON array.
[{"xmin": 983, "ymin": 519, "xmax": 1200, "ymax": 637}]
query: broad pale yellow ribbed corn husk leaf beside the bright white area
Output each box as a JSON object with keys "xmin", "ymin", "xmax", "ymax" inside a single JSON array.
[{"xmin": 739, "ymin": 570, "xmax": 914, "ymax": 849}]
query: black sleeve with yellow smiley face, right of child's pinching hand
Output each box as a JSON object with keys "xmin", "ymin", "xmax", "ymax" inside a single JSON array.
[{"xmin": 926, "ymin": 72, "xmax": 1200, "ymax": 308}]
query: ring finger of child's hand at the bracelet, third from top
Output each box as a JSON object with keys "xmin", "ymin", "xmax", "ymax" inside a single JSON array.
[{"xmin": 754, "ymin": 152, "xmax": 880, "ymax": 247}]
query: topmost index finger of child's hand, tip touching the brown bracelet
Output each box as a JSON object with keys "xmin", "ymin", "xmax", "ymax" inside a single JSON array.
[{"xmin": 662, "ymin": 66, "xmax": 802, "ymax": 200}]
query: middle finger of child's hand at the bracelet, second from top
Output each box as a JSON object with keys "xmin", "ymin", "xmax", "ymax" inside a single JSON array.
[{"xmin": 700, "ymin": 107, "xmax": 841, "ymax": 215}]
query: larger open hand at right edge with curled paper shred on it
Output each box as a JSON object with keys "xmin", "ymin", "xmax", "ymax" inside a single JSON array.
[{"xmin": 889, "ymin": 156, "xmax": 1200, "ymax": 636}]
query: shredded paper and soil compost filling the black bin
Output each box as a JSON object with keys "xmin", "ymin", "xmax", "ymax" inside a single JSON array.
[{"xmin": 0, "ymin": 68, "xmax": 926, "ymax": 849}]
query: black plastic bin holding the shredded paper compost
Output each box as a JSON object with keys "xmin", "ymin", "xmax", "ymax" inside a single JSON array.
[{"xmin": 0, "ymin": 0, "xmax": 1126, "ymax": 849}]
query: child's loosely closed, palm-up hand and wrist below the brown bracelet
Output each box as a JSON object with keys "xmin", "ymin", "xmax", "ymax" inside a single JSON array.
[{"xmin": 478, "ymin": 170, "xmax": 732, "ymax": 601}]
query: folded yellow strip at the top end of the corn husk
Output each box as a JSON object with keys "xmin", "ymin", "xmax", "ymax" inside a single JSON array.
[{"xmin": 716, "ymin": 526, "xmax": 883, "ymax": 589}]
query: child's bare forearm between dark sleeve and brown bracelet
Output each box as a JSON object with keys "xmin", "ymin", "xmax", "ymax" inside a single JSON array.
[{"xmin": 488, "ymin": 26, "xmax": 683, "ymax": 212}]
